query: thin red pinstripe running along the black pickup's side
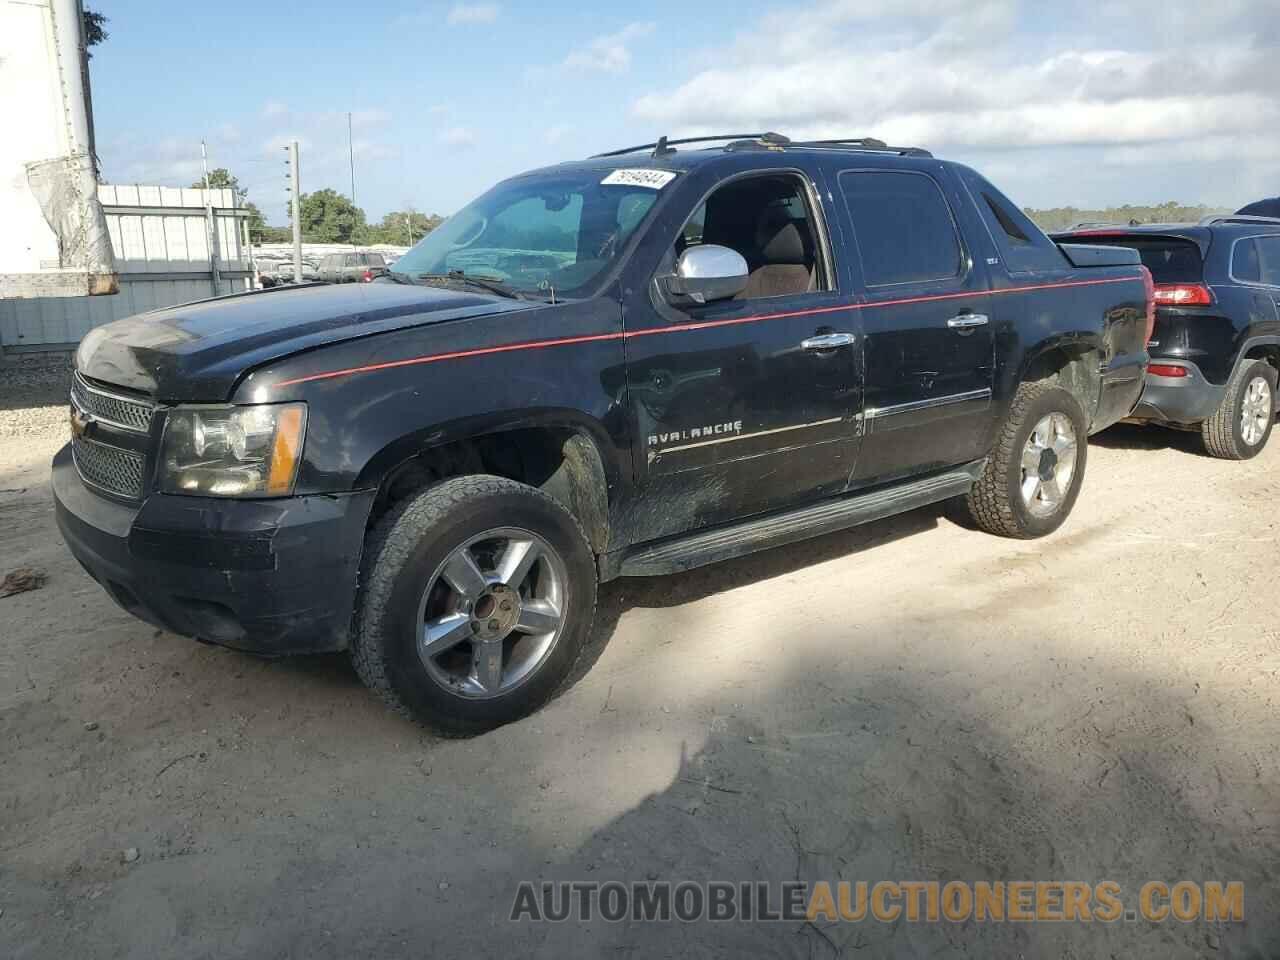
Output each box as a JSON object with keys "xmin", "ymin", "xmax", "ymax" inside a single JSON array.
[{"xmin": 275, "ymin": 276, "xmax": 1140, "ymax": 387}]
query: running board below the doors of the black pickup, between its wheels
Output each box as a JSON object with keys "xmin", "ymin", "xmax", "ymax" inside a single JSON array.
[{"xmin": 620, "ymin": 461, "xmax": 983, "ymax": 577}]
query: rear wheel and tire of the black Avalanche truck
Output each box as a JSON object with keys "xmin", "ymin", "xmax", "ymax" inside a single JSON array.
[{"xmin": 964, "ymin": 379, "xmax": 1089, "ymax": 540}]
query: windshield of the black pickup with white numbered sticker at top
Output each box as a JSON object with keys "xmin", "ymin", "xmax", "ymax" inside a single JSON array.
[{"xmin": 392, "ymin": 170, "xmax": 669, "ymax": 296}]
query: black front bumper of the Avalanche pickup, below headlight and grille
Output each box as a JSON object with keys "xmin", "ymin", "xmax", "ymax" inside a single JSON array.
[{"xmin": 52, "ymin": 445, "xmax": 374, "ymax": 654}]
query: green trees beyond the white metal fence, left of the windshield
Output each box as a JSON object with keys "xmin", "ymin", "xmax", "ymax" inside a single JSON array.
[{"xmin": 191, "ymin": 166, "xmax": 444, "ymax": 247}]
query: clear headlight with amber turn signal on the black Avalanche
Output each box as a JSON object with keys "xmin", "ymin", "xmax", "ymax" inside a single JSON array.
[{"xmin": 160, "ymin": 403, "xmax": 307, "ymax": 497}]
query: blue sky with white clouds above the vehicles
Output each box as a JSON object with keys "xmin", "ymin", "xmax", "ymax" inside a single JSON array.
[{"xmin": 88, "ymin": 0, "xmax": 1280, "ymax": 224}]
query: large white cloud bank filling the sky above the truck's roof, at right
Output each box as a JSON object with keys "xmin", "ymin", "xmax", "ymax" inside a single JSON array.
[{"xmin": 632, "ymin": 0, "xmax": 1280, "ymax": 207}]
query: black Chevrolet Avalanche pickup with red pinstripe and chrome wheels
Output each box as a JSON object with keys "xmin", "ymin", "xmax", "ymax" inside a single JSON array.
[{"xmin": 52, "ymin": 134, "xmax": 1153, "ymax": 735}]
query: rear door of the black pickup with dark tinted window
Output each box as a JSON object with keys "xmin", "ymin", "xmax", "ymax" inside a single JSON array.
[{"xmin": 836, "ymin": 161, "xmax": 995, "ymax": 486}]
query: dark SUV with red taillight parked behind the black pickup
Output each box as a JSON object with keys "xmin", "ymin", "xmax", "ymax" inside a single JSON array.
[{"xmin": 1056, "ymin": 214, "xmax": 1280, "ymax": 460}]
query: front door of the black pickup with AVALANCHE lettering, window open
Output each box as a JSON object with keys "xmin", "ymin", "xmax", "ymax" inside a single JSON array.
[{"xmin": 623, "ymin": 170, "xmax": 861, "ymax": 543}]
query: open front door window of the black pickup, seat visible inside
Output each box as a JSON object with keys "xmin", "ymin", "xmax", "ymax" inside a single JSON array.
[{"xmin": 676, "ymin": 174, "xmax": 831, "ymax": 300}]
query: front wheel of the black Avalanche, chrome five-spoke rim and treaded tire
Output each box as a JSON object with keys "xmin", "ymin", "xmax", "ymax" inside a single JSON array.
[{"xmin": 351, "ymin": 476, "xmax": 596, "ymax": 736}]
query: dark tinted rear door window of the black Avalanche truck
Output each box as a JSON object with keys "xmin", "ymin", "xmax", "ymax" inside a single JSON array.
[{"xmin": 840, "ymin": 170, "xmax": 961, "ymax": 287}]
